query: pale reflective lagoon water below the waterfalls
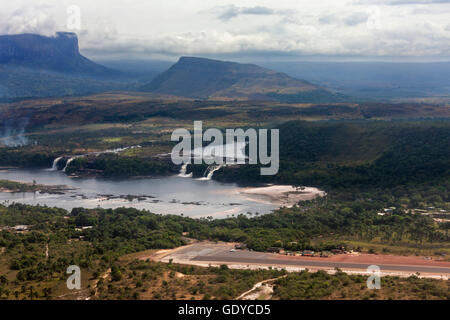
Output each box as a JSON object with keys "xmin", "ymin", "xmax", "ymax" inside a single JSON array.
[{"xmin": 0, "ymin": 169, "xmax": 277, "ymax": 218}]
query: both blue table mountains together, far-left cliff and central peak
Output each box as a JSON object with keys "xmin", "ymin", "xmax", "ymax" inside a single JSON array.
[{"xmin": 0, "ymin": 32, "xmax": 343, "ymax": 102}]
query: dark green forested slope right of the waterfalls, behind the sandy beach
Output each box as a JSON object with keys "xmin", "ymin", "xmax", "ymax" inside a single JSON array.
[{"xmin": 214, "ymin": 121, "xmax": 450, "ymax": 189}]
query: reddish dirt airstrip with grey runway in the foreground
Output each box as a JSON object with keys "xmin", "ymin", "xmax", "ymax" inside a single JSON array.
[{"xmin": 156, "ymin": 242, "xmax": 450, "ymax": 279}]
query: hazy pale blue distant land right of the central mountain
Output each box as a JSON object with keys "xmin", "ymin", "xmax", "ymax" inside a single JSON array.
[{"xmin": 261, "ymin": 61, "xmax": 450, "ymax": 101}]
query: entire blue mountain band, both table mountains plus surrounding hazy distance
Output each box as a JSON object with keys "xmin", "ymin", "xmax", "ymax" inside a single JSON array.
[{"xmin": 0, "ymin": 32, "xmax": 450, "ymax": 103}]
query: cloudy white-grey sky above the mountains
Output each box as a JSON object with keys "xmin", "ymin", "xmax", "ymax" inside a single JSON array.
[{"xmin": 0, "ymin": 0, "xmax": 450, "ymax": 60}]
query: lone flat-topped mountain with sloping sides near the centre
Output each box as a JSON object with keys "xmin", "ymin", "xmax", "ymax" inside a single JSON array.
[{"xmin": 142, "ymin": 57, "xmax": 344, "ymax": 102}]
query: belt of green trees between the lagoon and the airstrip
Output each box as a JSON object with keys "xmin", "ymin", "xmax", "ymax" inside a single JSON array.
[{"xmin": 0, "ymin": 178, "xmax": 450, "ymax": 282}]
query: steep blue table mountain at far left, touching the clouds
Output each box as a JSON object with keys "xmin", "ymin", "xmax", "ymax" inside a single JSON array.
[{"xmin": 0, "ymin": 32, "xmax": 128, "ymax": 101}]
